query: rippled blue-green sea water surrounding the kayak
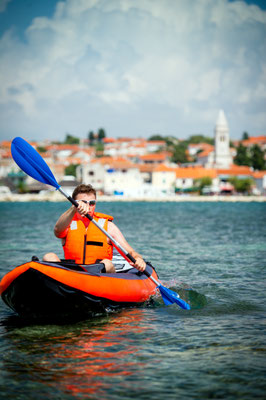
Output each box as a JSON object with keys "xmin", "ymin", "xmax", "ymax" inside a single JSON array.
[{"xmin": 0, "ymin": 203, "xmax": 266, "ymax": 400}]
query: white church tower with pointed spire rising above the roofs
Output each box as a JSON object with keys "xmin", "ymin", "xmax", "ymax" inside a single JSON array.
[{"xmin": 214, "ymin": 110, "xmax": 233, "ymax": 169}]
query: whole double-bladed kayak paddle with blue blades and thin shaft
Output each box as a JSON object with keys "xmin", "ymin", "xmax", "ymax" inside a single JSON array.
[{"xmin": 11, "ymin": 137, "xmax": 190, "ymax": 310}]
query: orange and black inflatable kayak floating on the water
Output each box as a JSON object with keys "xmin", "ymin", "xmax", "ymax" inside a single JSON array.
[{"xmin": 0, "ymin": 260, "xmax": 158, "ymax": 318}]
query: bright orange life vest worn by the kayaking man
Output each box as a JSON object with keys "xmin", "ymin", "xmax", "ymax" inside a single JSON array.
[{"xmin": 63, "ymin": 212, "xmax": 114, "ymax": 264}]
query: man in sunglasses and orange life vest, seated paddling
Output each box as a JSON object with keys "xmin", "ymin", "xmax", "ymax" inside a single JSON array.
[{"xmin": 43, "ymin": 184, "xmax": 146, "ymax": 273}]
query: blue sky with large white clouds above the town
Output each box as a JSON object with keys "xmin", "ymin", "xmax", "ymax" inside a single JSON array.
[{"xmin": 0, "ymin": 0, "xmax": 266, "ymax": 140}]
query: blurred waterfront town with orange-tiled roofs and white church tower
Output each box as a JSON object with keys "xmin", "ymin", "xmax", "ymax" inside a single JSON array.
[{"xmin": 0, "ymin": 110, "xmax": 266, "ymax": 201}]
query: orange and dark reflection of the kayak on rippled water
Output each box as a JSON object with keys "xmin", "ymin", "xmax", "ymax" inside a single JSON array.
[{"xmin": 3, "ymin": 309, "xmax": 151, "ymax": 398}]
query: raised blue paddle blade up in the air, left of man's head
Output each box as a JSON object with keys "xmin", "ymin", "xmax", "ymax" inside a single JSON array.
[{"xmin": 11, "ymin": 137, "xmax": 60, "ymax": 189}]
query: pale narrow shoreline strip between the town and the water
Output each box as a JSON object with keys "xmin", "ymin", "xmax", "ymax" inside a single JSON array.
[{"xmin": 0, "ymin": 191, "xmax": 266, "ymax": 203}]
